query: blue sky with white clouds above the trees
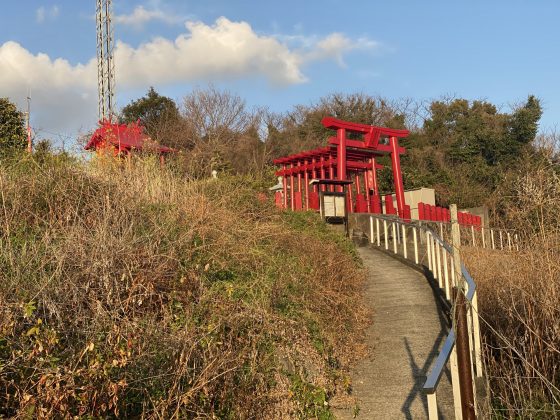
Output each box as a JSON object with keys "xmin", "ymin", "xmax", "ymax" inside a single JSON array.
[{"xmin": 0, "ymin": 0, "xmax": 560, "ymax": 146}]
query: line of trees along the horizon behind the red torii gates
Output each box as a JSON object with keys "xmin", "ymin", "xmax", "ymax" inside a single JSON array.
[{"xmin": 0, "ymin": 86, "xmax": 558, "ymax": 213}]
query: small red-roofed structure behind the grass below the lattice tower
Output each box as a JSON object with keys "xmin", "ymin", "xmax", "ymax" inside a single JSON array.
[{"xmin": 85, "ymin": 121, "xmax": 174, "ymax": 158}]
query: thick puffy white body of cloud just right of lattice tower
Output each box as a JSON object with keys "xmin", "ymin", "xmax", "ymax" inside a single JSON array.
[{"xmin": 115, "ymin": 17, "xmax": 306, "ymax": 86}]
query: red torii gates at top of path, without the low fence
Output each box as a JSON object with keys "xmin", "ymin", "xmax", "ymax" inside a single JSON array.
[{"xmin": 274, "ymin": 117, "xmax": 409, "ymax": 218}]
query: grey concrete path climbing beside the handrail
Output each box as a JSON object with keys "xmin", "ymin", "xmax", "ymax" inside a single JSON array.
[{"xmin": 334, "ymin": 248, "xmax": 454, "ymax": 420}]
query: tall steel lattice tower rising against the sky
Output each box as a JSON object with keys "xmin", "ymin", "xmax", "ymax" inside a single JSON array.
[{"xmin": 96, "ymin": 0, "xmax": 115, "ymax": 121}]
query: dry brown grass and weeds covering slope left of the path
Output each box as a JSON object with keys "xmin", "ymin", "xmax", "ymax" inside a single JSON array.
[{"xmin": 0, "ymin": 154, "xmax": 366, "ymax": 418}]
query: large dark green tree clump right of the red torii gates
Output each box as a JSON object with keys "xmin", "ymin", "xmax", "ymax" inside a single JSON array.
[{"xmin": 403, "ymin": 96, "xmax": 542, "ymax": 207}]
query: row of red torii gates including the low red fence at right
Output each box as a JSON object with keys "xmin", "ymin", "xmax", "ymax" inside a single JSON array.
[{"xmin": 274, "ymin": 117, "xmax": 481, "ymax": 226}]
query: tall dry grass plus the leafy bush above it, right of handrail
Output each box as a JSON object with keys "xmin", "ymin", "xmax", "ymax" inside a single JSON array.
[{"xmin": 465, "ymin": 166, "xmax": 560, "ymax": 419}]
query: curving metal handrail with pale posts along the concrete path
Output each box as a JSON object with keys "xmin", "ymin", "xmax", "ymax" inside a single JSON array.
[{"xmin": 360, "ymin": 214, "xmax": 482, "ymax": 420}]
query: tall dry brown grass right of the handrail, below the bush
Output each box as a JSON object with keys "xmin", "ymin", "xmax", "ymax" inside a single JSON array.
[{"xmin": 465, "ymin": 244, "xmax": 560, "ymax": 418}]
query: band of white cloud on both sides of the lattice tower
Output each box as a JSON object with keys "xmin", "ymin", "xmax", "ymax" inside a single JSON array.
[{"xmin": 0, "ymin": 17, "xmax": 378, "ymax": 136}]
